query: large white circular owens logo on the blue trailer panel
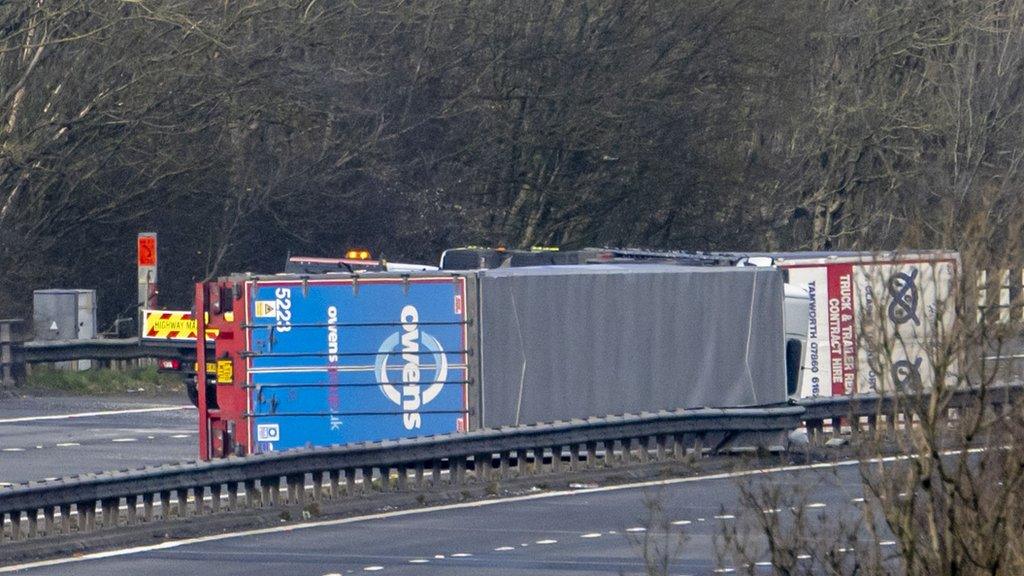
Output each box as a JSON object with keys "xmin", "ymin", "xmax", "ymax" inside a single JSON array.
[{"xmin": 374, "ymin": 305, "xmax": 447, "ymax": 430}]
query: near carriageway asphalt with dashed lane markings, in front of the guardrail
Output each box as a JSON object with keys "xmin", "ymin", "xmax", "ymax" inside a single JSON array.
[{"xmin": 0, "ymin": 455, "xmax": 891, "ymax": 576}]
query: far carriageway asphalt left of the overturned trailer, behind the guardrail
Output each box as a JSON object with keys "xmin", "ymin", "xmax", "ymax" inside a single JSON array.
[{"xmin": 0, "ymin": 397, "xmax": 197, "ymax": 486}]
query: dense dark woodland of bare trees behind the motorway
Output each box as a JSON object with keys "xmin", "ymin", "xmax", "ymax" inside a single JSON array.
[{"xmin": 0, "ymin": 0, "xmax": 1024, "ymax": 323}]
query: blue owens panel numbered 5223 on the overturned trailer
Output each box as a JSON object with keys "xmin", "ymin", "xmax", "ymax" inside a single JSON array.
[{"xmin": 247, "ymin": 277, "xmax": 468, "ymax": 452}]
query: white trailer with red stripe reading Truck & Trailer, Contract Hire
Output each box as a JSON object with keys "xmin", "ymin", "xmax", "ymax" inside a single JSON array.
[{"xmin": 737, "ymin": 250, "xmax": 959, "ymax": 398}]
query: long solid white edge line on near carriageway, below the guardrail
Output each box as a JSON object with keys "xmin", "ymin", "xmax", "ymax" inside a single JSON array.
[{"xmin": 0, "ymin": 448, "xmax": 986, "ymax": 574}]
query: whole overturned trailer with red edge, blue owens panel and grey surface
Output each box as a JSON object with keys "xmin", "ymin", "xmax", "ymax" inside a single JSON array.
[{"xmin": 197, "ymin": 264, "xmax": 787, "ymax": 456}]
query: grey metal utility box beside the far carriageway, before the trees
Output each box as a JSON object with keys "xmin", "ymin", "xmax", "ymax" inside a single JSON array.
[{"xmin": 32, "ymin": 288, "xmax": 96, "ymax": 370}]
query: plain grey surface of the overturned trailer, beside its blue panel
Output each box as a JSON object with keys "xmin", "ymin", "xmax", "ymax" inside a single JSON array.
[{"xmin": 477, "ymin": 264, "xmax": 787, "ymax": 426}]
